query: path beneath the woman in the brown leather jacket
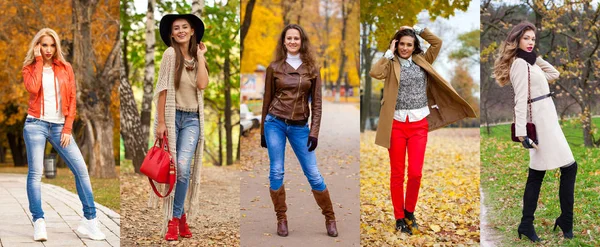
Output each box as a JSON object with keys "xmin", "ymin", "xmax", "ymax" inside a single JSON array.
[{"xmin": 240, "ymin": 102, "xmax": 360, "ymax": 247}]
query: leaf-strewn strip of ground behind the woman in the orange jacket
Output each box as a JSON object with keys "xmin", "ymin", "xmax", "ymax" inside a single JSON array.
[{"xmin": 0, "ymin": 165, "xmax": 121, "ymax": 213}]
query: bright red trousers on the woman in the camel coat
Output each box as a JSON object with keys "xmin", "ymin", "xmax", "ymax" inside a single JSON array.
[{"xmin": 388, "ymin": 118, "xmax": 429, "ymax": 219}]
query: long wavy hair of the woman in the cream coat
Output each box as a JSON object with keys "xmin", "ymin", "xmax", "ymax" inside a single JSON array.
[{"xmin": 494, "ymin": 21, "xmax": 535, "ymax": 87}]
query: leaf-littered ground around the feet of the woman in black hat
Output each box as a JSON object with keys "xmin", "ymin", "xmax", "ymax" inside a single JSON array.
[{"xmin": 121, "ymin": 165, "xmax": 240, "ymax": 246}]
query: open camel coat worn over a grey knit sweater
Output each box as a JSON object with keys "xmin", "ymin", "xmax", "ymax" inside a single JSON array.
[{"xmin": 369, "ymin": 28, "xmax": 477, "ymax": 148}]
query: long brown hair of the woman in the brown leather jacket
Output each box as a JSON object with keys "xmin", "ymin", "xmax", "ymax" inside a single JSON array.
[{"xmin": 275, "ymin": 24, "xmax": 316, "ymax": 72}]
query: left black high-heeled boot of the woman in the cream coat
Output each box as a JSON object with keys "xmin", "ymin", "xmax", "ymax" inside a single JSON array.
[{"xmin": 518, "ymin": 168, "xmax": 546, "ymax": 242}]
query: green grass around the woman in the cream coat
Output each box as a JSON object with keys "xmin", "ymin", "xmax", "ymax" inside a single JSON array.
[{"xmin": 481, "ymin": 118, "xmax": 600, "ymax": 246}]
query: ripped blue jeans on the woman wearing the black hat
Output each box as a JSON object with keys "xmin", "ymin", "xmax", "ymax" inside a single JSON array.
[{"xmin": 173, "ymin": 110, "xmax": 200, "ymax": 218}]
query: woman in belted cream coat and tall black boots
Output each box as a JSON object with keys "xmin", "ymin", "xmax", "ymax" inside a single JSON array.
[{"xmin": 494, "ymin": 22, "xmax": 577, "ymax": 242}]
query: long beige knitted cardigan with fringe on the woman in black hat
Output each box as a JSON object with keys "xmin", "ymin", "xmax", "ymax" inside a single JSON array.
[{"xmin": 148, "ymin": 47, "xmax": 204, "ymax": 234}]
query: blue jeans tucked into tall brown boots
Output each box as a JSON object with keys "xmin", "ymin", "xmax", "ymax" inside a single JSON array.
[{"xmin": 264, "ymin": 114, "xmax": 327, "ymax": 191}]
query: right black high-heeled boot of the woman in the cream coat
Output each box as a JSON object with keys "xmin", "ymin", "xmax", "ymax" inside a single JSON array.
[{"xmin": 554, "ymin": 162, "xmax": 577, "ymax": 238}]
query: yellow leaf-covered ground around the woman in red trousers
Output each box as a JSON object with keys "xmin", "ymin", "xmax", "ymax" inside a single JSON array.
[{"xmin": 360, "ymin": 129, "xmax": 480, "ymax": 246}]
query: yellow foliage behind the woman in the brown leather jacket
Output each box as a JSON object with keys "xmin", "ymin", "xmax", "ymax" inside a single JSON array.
[{"xmin": 241, "ymin": 0, "xmax": 360, "ymax": 86}]
